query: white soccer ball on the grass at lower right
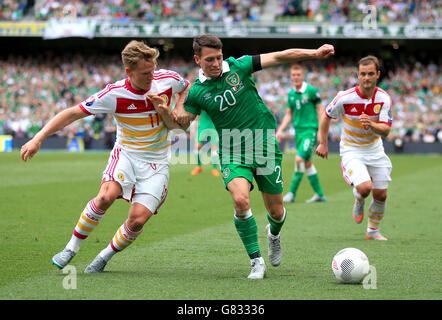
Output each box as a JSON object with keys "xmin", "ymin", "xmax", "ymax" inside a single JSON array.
[{"xmin": 332, "ymin": 248, "xmax": 370, "ymax": 283}]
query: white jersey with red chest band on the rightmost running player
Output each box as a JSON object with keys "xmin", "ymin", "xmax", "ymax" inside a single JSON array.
[{"xmin": 325, "ymin": 86, "xmax": 393, "ymax": 155}]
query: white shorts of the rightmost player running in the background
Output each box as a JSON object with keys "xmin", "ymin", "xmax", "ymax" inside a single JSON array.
[{"xmin": 341, "ymin": 154, "xmax": 392, "ymax": 189}]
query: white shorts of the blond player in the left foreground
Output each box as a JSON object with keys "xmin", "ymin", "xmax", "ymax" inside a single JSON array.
[{"xmin": 102, "ymin": 147, "xmax": 169, "ymax": 214}]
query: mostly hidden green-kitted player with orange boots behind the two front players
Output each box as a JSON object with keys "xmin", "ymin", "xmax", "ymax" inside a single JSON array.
[{"xmin": 190, "ymin": 110, "xmax": 220, "ymax": 177}]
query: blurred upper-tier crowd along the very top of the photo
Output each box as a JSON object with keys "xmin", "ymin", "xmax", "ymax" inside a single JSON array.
[{"xmin": 0, "ymin": 0, "xmax": 442, "ymax": 23}]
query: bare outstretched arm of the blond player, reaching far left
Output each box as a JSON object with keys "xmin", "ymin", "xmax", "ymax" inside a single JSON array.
[{"xmin": 20, "ymin": 106, "xmax": 88, "ymax": 161}]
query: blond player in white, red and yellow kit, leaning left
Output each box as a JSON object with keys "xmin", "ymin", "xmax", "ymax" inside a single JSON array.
[{"xmin": 21, "ymin": 40, "xmax": 189, "ymax": 273}]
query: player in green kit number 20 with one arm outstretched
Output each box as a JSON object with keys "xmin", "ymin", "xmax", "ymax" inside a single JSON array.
[{"xmin": 174, "ymin": 35, "xmax": 334, "ymax": 279}]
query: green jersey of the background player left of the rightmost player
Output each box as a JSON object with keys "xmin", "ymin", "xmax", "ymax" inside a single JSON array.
[{"xmin": 287, "ymin": 82, "xmax": 321, "ymax": 130}]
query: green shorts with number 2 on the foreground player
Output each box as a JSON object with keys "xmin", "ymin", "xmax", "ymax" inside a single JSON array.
[{"xmin": 221, "ymin": 156, "xmax": 283, "ymax": 194}]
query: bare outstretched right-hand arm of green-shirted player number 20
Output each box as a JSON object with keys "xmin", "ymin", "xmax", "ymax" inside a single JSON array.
[{"xmin": 261, "ymin": 44, "xmax": 335, "ymax": 69}]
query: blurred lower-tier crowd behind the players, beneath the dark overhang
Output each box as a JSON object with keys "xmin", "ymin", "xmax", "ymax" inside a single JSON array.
[{"xmin": 0, "ymin": 54, "xmax": 442, "ymax": 142}]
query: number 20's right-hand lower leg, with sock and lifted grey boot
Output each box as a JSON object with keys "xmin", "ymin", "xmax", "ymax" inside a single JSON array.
[{"xmin": 262, "ymin": 192, "xmax": 286, "ymax": 267}]
